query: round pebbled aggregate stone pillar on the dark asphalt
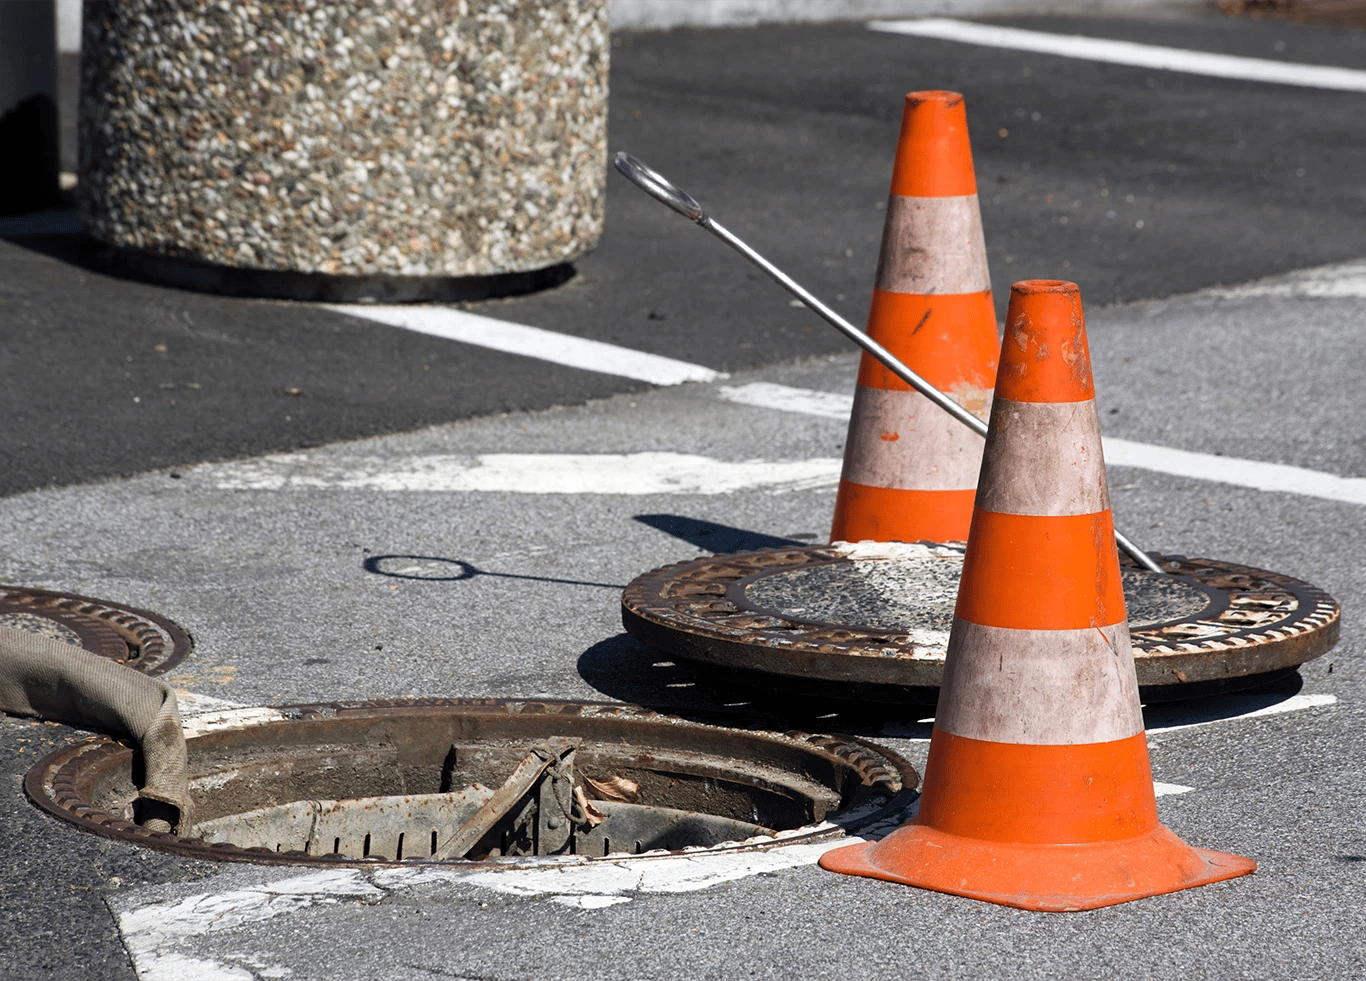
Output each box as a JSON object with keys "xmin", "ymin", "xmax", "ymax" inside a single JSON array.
[{"xmin": 79, "ymin": 0, "xmax": 609, "ymax": 301}]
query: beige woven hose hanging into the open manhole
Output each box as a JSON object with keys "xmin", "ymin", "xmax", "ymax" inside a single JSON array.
[{"xmin": 0, "ymin": 627, "xmax": 191, "ymax": 832}]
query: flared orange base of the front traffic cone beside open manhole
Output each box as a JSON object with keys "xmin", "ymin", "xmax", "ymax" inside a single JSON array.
[{"xmin": 821, "ymin": 824, "xmax": 1257, "ymax": 913}]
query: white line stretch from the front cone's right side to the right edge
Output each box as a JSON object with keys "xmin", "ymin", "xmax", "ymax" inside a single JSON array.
[{"xmin": 1105, "ymin": 437, "xmax": 1366, "ymax": 504}]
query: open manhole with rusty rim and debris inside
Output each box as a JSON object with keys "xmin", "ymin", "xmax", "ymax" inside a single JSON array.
[{"xmin": 25, "ymin": 700, "xmax": 919, "ymax": 865}]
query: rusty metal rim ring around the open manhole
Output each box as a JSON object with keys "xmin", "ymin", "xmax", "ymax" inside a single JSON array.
[{"xmin": 23, "ymin": 698, "xmax": 921, "ymax": 870}]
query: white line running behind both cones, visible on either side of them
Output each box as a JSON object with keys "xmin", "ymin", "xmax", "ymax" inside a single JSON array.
[{"xmin": 719, "ymin": 382, "xmax": 1366, "ymax": 504}]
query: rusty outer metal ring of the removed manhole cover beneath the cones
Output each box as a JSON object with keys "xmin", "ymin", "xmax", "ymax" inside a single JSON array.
[{"xmin": 622, "ymin": 545, "xmax": 1341, "ymax": 701}]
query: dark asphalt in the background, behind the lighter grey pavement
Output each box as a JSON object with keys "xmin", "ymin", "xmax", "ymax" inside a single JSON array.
[{"xmin": 0, "ymin": 7, "xmax": 1366, "ymax": 493}]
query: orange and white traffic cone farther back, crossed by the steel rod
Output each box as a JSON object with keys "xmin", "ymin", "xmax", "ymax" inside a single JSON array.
[{"xmin": 831, "ymin": 92, "xmax": 1000, "ymax": 541}]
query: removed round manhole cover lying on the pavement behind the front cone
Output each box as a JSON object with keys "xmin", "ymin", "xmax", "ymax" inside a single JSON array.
[{"xmin": 622, "ymin": 542, "xmax": 1340, "ymax": 702}]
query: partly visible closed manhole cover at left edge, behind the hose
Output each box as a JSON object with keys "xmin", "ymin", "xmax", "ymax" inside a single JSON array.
[{"xmin": 0, "ymin": 586, "xmax": 193, "ymax": 675}]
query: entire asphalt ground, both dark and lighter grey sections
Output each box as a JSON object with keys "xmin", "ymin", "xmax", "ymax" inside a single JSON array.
[{"xmin": 0, "ymin": 7, "xmax": 1366, "ymax": 981}]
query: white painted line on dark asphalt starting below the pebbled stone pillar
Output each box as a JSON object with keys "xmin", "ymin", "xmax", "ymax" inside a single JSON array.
[{"xmin": 324, "ymin": 305, "xmax": 725, "ymax": 385}]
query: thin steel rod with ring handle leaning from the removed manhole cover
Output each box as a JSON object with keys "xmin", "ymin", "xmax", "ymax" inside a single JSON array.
[{"xmin": 615, "ymin": 152, "xmax": 1165, "ymax": 575}]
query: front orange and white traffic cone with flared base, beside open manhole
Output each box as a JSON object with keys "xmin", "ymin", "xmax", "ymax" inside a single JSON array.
[{"xmin": 821, "ymin": 280, "xmax": 1257, "ymax": 910}]
